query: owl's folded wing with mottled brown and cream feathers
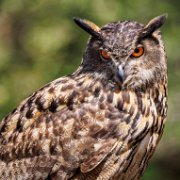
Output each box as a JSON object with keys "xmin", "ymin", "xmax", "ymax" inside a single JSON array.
[{"xmin": 0, "ymin": 81, "xmax": 141, "ymax": 177}]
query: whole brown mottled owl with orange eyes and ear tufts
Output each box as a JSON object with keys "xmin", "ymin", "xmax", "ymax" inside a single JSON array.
[{"xmin": 0, "ymin": 15, "xmax": 167, "ymax": 180}]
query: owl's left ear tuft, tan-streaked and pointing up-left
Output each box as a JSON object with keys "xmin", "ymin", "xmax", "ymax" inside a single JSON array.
[{"xmin": 73, "ymin": 17, "xmax": 102, "ymax": 40}]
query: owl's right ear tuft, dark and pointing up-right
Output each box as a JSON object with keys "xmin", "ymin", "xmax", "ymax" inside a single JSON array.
[{"xmin": 141, "ymin": 14, "xmax": 168, "ymax": 38}]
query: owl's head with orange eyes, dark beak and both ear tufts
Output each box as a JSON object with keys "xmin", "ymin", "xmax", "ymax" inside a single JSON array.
[{"xmin": 74, "ymin": 15, "xmax": 167, "ymax": 89}]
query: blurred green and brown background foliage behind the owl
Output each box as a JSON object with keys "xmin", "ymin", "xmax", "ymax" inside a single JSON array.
[{"xmin": 0, "ymin": 0, "xmax": 180, "ymax": 180}]
